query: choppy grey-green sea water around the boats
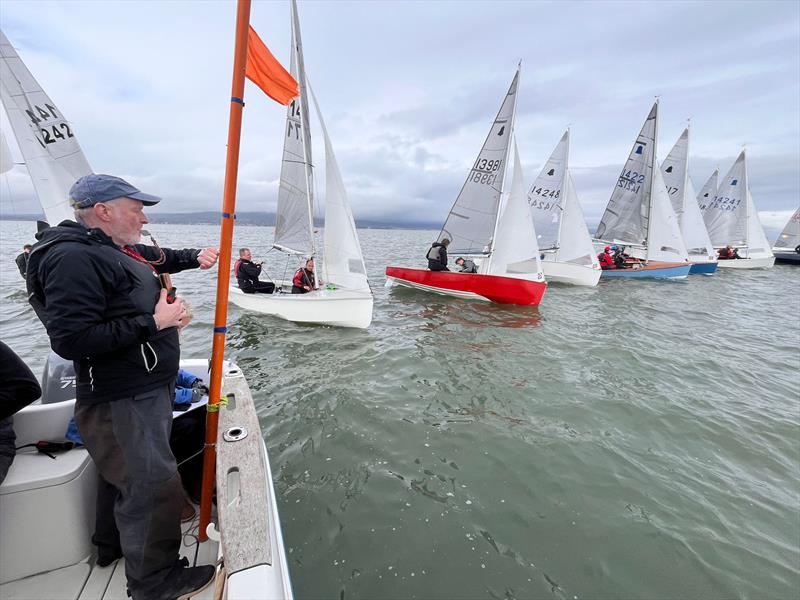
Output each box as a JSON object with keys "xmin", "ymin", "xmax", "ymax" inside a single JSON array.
[{"xmin": 0, "ymin": 222, "xmax": 800, "ymax": 599}]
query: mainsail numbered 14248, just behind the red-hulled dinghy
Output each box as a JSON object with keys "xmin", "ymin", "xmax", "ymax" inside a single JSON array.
[{"xmin": 528, "ymin": 131, "xmax": 569, "ymax": 250}]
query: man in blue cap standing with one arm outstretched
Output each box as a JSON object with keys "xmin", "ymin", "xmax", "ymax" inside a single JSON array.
[{"xmin": 28, "ymin": 174, "xmax": 219, "ymax": 600}]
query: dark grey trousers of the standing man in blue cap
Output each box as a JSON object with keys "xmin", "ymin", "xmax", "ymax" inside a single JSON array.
[{"xmin": 75, "ymin": 385, "xmax": 183, "ymax": 591}]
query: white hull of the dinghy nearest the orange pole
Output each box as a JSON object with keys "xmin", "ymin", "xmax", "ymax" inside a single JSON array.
[{"xmin": 230, "ymin": 286, "xmax": 372, "ymax": 329}]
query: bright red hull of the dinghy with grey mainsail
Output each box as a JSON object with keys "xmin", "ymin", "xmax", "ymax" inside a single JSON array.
[{"xmin": 386, "ymin": 267, "xmax": 547, "ymax": 306}]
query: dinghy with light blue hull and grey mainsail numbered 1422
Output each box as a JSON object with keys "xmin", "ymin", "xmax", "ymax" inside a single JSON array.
[{"xmin": 595, "ymin": 101, "xmax": 691, "ymax": 279}]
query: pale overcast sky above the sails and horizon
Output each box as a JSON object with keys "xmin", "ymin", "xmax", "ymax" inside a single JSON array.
[{"xmin": 0, "ymin": 0, "xmax": 800, "ymax": 230}]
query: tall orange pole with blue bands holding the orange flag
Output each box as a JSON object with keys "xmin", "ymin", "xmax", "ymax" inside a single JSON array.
[{"xmin": 199, "ymin": 0, "xmax": 250, "ymax": 542}]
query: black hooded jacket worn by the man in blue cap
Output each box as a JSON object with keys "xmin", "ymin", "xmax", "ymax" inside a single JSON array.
[{"xmin": 28, "ymin": 221, "xmax": 199, "ymax": 404}]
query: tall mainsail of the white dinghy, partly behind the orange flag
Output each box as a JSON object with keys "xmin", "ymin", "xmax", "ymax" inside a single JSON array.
[{"xmin": 275, "ymin": 2, "xmax": 314, "ymax": 256}]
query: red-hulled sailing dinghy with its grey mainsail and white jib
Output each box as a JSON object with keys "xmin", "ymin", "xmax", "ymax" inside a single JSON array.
[{"xmin": 386, "ymin": 68, "xmax": 547, "ymax": 305}]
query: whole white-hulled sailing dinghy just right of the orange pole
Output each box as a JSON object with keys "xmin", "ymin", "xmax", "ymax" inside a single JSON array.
[{"xmin": 230, "ymin": 0, "xmax": 373, "ymax": 329}]
